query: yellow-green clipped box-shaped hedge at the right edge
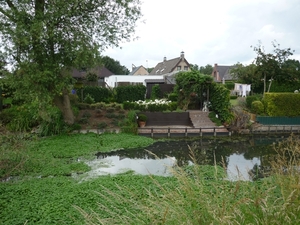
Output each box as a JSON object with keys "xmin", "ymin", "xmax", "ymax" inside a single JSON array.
[{"xmin": 264, "ymin": 93, "xmax": 300, "ymax": 117}]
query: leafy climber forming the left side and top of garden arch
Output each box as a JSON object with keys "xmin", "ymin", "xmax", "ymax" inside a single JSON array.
[{"xmin": 174, "ymin": 70, "xmax": 213, "ymax": 110}]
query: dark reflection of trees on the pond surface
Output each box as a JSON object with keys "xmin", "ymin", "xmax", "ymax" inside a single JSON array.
[{"xmin": 97, "ymin": 138, "xmax": 282, "ymax": 167}]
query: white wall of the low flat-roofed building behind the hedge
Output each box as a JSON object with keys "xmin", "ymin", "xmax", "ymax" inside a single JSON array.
[{"xmin": 104, "ymin": 75, "xmax": 164, "ymax": 88}]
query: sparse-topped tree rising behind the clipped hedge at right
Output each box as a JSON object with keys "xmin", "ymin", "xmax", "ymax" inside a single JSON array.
[{"xmin": 253, "ymin": 41, "xmax": 293, "ymax": 93}]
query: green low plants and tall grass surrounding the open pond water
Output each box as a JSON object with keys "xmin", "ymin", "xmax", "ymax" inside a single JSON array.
[{"xmin": 0, "ymin": 134, "xmax": 300, "ymax": 224}]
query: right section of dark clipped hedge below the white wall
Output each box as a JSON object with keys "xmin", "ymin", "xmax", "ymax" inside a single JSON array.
[{"xmin": 115, "ymin": 85, "xmax": 146, "ymax": 103}]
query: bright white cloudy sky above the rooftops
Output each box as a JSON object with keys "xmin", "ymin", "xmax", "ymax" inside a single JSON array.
[{"xmin": 102, "ymin": 0, "xmax": 300, "ymax": 71}]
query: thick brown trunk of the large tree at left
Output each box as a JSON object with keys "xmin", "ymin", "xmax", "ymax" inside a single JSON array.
[{"xmin": 54, "ymin": 90, "xmax": 75, "ymax": 125}]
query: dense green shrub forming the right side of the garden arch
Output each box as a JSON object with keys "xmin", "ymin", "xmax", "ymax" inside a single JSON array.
[{"xmin": 209, "ymin": 83, "xmax": 233, "ymax": 122}]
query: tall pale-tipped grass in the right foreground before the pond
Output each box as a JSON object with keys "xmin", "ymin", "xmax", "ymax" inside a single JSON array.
[{"xmin": 77, "ymin": 135, "xmax": 300, "ymax": 224}]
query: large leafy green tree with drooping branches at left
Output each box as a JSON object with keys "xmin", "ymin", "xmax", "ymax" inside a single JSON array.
[{"xmin": 0, "ymin": 0, "xmax": 141, "ymax": 124}]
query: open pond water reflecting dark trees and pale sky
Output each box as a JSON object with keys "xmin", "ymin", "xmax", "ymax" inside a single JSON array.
[{"xmin": 81, "ymin": 137, "xmax": 286, "ymax": 180}]
